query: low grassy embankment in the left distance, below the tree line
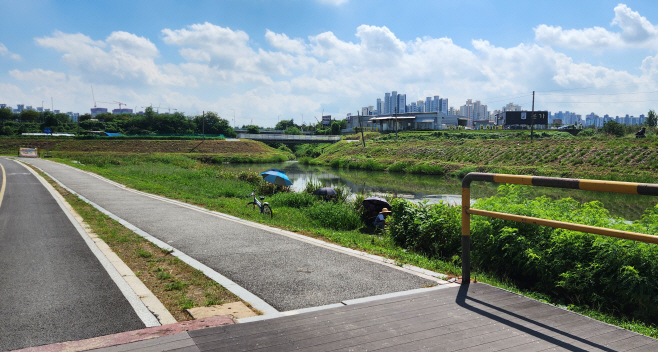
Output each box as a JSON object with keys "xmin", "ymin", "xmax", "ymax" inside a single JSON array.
[{"xmin": 0, "ymin": 137, "xmax": 294, "ymax": 163}]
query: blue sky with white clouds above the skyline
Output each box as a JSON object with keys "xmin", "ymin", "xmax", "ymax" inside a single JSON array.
[{"xmin": 0, "ymin": 0, "xmax": 658, "ymax": 127}]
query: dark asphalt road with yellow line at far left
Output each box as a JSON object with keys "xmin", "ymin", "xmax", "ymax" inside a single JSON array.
[{"xmin": 0, "ymin": 158, "xmax": 145, "ymax": 351}]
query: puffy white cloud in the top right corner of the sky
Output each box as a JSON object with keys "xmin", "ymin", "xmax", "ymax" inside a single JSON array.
[{"xmin": 535, "ymin": 4, "xmax": 658, "ymax": 50}]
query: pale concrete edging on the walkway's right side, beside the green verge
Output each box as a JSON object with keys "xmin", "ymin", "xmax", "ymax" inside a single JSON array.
[{"xmin": 46, "ymin": 163, "xmax": 448, "ymax": 285}]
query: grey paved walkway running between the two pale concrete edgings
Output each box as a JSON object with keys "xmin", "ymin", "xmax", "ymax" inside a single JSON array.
[{"xmin": 24, "ymin": 159, "xmax": 437, "ymax": 311}]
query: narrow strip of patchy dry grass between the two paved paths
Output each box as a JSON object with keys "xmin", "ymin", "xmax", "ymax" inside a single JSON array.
[{"xmin": 28, "ymin": 165, "xmax": 249, "ymax": 321}]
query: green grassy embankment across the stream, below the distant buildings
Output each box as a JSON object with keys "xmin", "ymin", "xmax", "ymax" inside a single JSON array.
[{"xmin": 300, "ymin": 131, "xmax": 658, "ymax": 182}]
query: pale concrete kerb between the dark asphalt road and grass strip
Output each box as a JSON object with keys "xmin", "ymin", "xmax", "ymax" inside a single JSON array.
[{"xmin": 14, "ymin": 159, "xmax": 161, "ymax": 328}]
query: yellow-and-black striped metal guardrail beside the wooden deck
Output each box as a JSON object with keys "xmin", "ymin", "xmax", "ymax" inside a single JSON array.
[{"xmin": 462, "ymin": 172, "xmax": 658, "ymax": 284}]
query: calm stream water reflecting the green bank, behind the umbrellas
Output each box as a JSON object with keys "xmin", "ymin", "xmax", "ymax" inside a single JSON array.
[{"xmin": 225, "ymin": 161, "xmax": 658, "ymax": 220}]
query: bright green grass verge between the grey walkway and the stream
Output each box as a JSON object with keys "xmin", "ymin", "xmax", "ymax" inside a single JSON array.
[{"xmin": 44, "ymin": 156, "xmax": 658, "ymax": 336}]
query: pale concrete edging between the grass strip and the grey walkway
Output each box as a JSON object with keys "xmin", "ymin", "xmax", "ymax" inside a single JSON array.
[{"xmin": 23, "ymin": 164, "xmax": 280, "ymax": 316}]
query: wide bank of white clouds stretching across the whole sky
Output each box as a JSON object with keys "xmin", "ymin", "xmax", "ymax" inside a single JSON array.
[{"xmin": 10, "ymin": 10, "xmax": 658, "ymax": 126}]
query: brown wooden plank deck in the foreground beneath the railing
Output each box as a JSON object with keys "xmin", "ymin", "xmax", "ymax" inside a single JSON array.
[{"xmin": 93, "ymin": 283, "xmax": 658, "ymax": 352}]
